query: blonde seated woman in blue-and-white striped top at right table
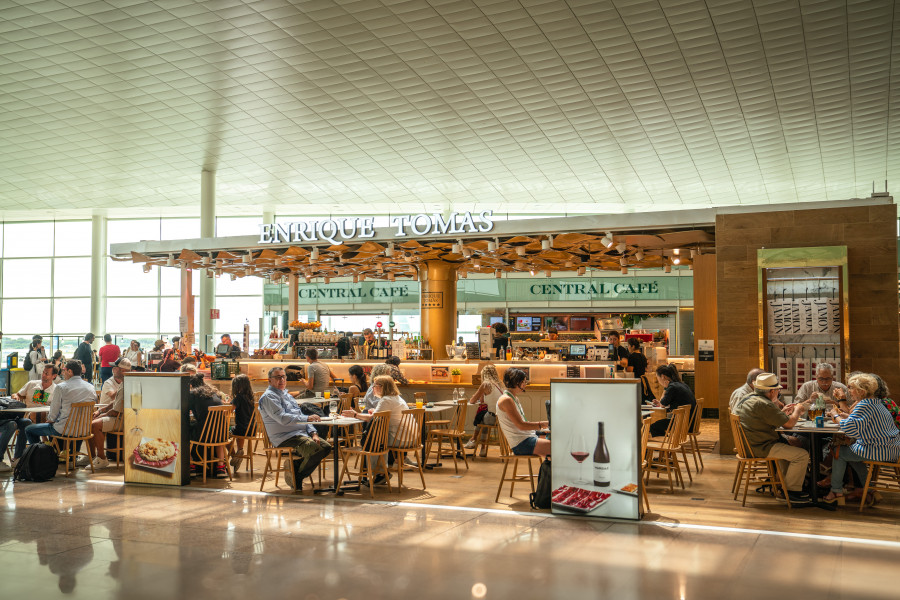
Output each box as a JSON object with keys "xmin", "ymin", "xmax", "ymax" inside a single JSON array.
[{"xmin": 824, "ymin": 374, "xmax": 900, "ymax": 504}]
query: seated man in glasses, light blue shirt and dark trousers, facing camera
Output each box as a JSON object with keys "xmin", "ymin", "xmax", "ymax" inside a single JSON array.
[{"xmin": 259, "ymin": 367, "xmax": 337, "ymax": 490}]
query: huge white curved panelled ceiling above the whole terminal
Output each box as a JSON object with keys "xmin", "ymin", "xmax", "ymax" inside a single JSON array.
[{"xmin": 0, "ymin": 0, "xmax": 900, "ymax": 219}]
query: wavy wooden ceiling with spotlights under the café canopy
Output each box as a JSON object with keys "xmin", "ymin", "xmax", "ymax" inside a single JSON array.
[{"xmin": 114, "ymin": 229, "xmax": 715, "ymax": 281}]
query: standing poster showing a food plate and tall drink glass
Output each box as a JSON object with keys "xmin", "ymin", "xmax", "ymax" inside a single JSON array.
[{"xmin": 123, "ymin": 372, "xmax": 191, "ymax": 485}]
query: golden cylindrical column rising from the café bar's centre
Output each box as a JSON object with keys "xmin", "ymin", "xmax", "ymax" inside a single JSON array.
[{"xmin": 419, "ymin": 260, "xmax": 457, "ymax": 360}]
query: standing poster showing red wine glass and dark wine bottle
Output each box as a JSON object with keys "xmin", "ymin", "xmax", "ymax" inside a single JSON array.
[{"xmin": 550, "ymin": 379, "xmax": 642, "ymax": 519}]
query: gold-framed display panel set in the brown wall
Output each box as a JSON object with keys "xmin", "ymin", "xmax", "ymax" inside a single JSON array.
[{"xmin": 757, "ymin": 246, "xmax": 850, "ymax": 396}]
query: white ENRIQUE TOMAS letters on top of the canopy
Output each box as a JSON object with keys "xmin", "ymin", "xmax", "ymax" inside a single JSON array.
[{"xmin": 259, "ymin": 210, "xmax": 494, "ymax": 246}]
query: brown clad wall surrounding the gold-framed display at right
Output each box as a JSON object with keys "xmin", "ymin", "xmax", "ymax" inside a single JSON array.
[{"xmin": 708, "ymin": 200, "xmax": 900, "ymax": 454}]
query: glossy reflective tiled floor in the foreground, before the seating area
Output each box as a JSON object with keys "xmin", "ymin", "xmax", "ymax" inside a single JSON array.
[{"xmin": 0, "ymin": 478, "xmax": 900, "ymax": 600}]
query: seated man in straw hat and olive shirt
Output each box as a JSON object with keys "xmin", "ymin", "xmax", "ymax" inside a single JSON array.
[{"xmin": 735, "ymin": 373, "xmax": 809, "ymax": 502}]
